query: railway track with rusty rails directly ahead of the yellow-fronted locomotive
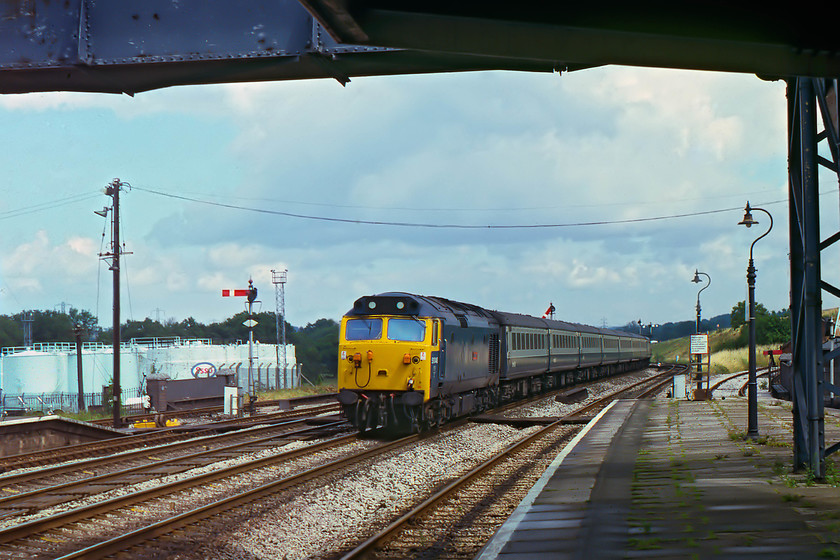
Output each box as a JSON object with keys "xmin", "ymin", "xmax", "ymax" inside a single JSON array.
[{"xmin": 0, "ymin": 368, "xmax": 668, "ymax": 558}]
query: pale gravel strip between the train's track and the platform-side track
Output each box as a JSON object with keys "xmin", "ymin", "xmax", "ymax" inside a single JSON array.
[{"xmin": 154, "ymin": 370, "xmax": 652, "ymax": 560}]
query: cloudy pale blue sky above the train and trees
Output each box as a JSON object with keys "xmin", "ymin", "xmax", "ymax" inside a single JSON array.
[{"xmin": 0, "ymin": 66, "xmax": 838, "ymax": 327}]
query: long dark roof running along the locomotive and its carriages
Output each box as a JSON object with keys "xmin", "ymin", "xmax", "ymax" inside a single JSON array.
[{"xmin": 347, "ymin": 292, "xmax": 647, "ymax": 340}]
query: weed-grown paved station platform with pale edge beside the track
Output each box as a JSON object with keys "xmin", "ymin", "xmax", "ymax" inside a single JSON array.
[{"xmin": 476, "ymin": 396, "xmax": 840, "ymax": 560}]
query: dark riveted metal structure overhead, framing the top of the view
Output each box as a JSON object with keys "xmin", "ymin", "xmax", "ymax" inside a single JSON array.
[{"xmin": 0, "ymin": 0, "xmax": 840, "ymax": 94}]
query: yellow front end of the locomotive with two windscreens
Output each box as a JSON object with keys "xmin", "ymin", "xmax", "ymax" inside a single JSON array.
[{"xmin": 338, "ymin": 297, "xmax": 440, "ymax": 430}]
